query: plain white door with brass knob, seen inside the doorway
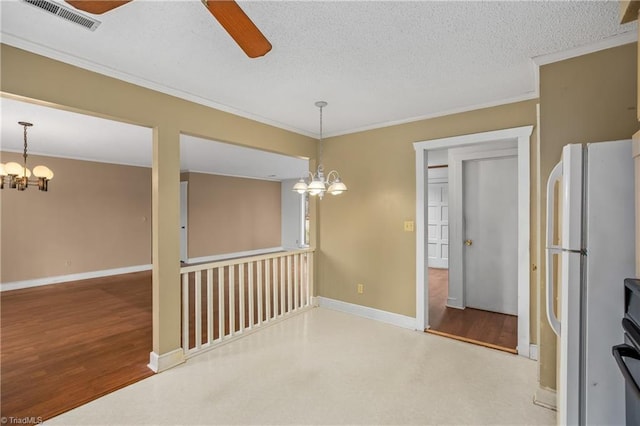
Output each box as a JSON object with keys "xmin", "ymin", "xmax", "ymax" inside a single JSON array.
[{"xmin": 462, "ymin": 156, "xmax": 518, "ymax": 315}]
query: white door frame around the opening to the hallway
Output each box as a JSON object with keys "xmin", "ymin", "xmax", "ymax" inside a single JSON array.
[{"xmin": 413, "ymin": 126, "xmax": 533, "ymax": 357}]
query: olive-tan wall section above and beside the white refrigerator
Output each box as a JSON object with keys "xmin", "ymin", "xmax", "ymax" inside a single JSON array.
[{"xmin": 539, "ymin": 43, "xmax": 638, "ymax": 389}]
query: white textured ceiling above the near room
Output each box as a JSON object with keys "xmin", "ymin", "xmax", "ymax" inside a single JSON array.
[{"xmin": 0, "ymin": 0, "xmax": 637, "ymax": 135}]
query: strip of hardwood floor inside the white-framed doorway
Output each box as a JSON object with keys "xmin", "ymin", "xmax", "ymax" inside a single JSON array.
[{"xmin": 427, "ymin": 268, "xmax": 518, "ymax": 353}]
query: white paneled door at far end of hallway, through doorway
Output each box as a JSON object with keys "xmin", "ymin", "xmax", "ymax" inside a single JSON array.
[{"xmin": 427, "ymin": 168, "xmax": 449, "ymax": 268}]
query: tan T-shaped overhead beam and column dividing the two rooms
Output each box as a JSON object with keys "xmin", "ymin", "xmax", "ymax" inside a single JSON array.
[{"xmin": 0, "ymin": 44, "xmax": 317, "ymax": 355}]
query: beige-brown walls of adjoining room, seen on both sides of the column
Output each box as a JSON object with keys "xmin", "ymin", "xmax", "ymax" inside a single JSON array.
[{"xmin": 0, "ymin": 152, "xmax": 281, "ymax": 283}]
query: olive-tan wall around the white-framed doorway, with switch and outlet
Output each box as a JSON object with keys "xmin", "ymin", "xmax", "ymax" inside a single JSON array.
[{"xmin": 318, "ymin": 100, "xmax": 537, "ymax": 324}]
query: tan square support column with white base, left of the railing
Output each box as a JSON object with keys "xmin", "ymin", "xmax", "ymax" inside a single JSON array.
[{"xmin": 148, "ymin": 126, "xmax": 184, "ymax": 373}]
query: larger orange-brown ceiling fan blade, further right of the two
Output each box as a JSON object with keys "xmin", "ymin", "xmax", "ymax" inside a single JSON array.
[{"xmin": 202, "ymin": 0, "xmax": 271, "ymax": 58}]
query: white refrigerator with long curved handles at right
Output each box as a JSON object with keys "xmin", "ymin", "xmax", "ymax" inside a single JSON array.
[{"xmin": 546, "ymin": 140, "xmax": 635, "ymax": 425}]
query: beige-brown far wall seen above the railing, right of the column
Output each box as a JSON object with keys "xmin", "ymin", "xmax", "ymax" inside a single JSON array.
[{"xmin": 183, "ymin": 173, "xmax": 281, "ymax": 258}]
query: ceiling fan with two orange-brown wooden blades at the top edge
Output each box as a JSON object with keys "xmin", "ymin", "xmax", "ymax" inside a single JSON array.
[{"xmin": 66, "ymin": 0, "xmax": 271, "ymax": 58}]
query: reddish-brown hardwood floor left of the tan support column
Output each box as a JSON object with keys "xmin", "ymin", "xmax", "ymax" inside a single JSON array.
[{"xmin": 0, "ymin": 271, "xmax": 153, "ymax": 424}]
